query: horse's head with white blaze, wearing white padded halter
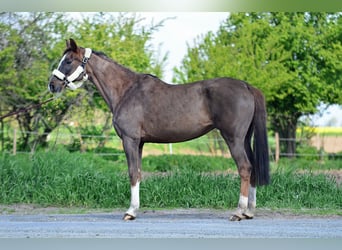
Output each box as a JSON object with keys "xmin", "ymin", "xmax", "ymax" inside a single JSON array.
[{"xmin": 48, "ymin": 39, "xmax": 91, "ymax": 93}]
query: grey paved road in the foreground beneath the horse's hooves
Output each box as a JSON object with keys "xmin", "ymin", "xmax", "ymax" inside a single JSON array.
[{"xmin": 0, "ymin": 209, "xmax": 342, "ymax": 238}]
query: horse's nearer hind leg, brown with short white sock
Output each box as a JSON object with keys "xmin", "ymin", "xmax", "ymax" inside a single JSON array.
[{"xmin": 222, "ymin": 133, "xmax": 252, "ymax": 221}]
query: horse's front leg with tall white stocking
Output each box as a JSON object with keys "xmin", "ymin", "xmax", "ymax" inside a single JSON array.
[{"xmin": 123, "ymin": 137, "xmax": 143, "ymax": 220}]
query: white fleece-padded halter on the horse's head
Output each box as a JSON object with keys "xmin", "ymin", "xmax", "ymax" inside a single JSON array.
[{"xmin": 52, "ymin": 48, "xmax": 92, "ymax": 90}]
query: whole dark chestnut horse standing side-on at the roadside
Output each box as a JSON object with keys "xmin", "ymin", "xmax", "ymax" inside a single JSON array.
[{"xmin": 49, "ymin": 39, "xmax": 269, "ymax": 220}]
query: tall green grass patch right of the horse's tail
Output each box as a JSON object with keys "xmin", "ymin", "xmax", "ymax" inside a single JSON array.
[{"xmin": 258, "ymin": 170, "xmax": 342, "ymax": 209}]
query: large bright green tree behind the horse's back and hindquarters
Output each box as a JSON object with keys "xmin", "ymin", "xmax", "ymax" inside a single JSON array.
[{"xmin": 175, "ymin": 13, "xmax": 342, "ymax": 156}]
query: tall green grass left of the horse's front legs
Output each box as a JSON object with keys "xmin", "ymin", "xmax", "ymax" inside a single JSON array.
[{"xmin": 0, "ymin": 151, "xmax": 129, "ymax": 207}]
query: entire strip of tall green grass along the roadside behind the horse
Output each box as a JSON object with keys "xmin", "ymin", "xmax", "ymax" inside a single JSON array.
[{"xmin": 0, "ymin": 149, "xmax": 342, "ymax": 211}]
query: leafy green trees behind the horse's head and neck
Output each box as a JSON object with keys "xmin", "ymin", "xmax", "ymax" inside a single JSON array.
[{"xmin": 0, "ymin": 13, "xmax": 166, "ymax": 150}]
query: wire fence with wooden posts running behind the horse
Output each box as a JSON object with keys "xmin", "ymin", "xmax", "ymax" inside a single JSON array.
[{"xmin": 0, "ymin": 129, "xmax": 342, "ymax": 161}]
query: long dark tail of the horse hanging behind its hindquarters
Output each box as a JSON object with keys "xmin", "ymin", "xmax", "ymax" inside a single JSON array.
[{"xmin": 250, "ymin": 87, "xmax": 270, "ymax": 186}]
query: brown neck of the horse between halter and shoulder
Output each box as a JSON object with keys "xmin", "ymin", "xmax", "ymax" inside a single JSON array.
[{"xmin": 87, "ymin": 54, "xmax": 138, "ymax": 113}]
